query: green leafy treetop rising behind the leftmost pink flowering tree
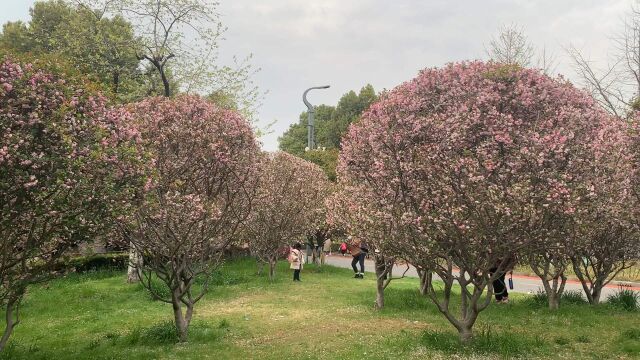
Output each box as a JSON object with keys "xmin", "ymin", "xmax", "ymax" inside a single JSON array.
[{"xmin": 0, "ymin": 0, "xmax": 146, "ymax": 102}]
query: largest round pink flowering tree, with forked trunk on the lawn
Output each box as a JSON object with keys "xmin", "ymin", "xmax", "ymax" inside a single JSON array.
[{"xmin": 338, "ymin": 62, "xmax": 608, "ymax": 341}]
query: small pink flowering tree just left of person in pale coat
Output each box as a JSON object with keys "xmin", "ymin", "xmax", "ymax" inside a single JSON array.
[{"xmin": 245, "ymin": 151, "xmax": 330, "ymax": 280}]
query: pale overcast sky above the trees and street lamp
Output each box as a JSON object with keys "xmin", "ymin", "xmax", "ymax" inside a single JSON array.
[{"xmin": 0, "ymin": 0, "xmax": 632, "ymax": 150}]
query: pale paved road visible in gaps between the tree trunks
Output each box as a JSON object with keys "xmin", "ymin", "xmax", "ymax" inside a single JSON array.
[{"xmin": 326, "ymin": 254, "xmax": 640, "ymax": 301}]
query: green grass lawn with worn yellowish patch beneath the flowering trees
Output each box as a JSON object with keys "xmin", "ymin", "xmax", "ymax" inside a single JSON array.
[{"xmin": 0, "ymin": 260, "xmax": 640, "ymax": 360}]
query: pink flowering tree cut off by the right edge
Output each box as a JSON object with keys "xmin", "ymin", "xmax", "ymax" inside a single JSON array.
[{"xmin": 571, "ymin": 119, "xmax": 640, "ymax": 304}]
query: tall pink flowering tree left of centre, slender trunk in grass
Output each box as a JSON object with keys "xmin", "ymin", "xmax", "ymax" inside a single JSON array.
[{"xmin": 122, "ymin": 96, "xmax": 259, "ymax": 341}]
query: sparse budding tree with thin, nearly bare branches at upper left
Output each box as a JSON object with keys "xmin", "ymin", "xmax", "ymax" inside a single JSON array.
[{"xmin": 72, "ymin": 0, "xmax": 262, "ymax": 112}]
